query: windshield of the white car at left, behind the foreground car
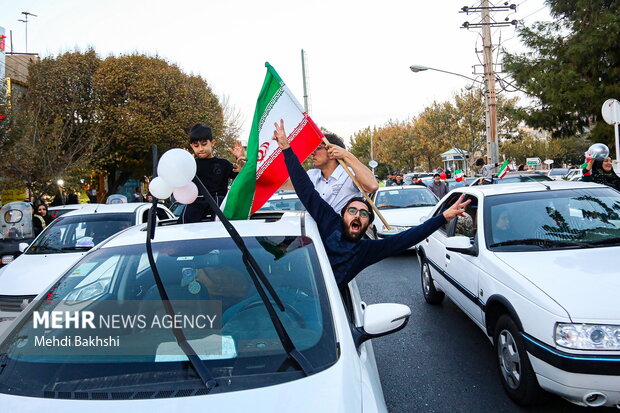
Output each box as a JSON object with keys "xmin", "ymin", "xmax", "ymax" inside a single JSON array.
[{"xmin": 26, "ymin": 213, "xmax": 135, "ymax": 254}]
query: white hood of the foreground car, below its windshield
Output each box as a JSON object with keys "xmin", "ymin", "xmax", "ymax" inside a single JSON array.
[{"xmin": 0, "ymin": 357, "xmax": 364, "ymax": 413}]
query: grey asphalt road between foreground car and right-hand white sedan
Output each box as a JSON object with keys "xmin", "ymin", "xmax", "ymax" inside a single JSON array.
[{"xmin": 357, "ymin": 249, "xmax": 618, "ymax": 413}]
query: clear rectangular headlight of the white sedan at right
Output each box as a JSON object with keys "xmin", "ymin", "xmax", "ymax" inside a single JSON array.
[{"xmin": 555, "ymin": 323, "xmax": 620, "ymax": 350}]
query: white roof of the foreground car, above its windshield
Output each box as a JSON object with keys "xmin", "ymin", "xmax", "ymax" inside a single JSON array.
[{"xmin": 101, "ymin": 211, "xmax": 310, "ymax": 248}]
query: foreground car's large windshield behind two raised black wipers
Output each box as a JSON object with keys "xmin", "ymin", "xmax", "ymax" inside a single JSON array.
[{"xmin": 0, "ymin": 236, "xmax": 338, "ymax": 400}]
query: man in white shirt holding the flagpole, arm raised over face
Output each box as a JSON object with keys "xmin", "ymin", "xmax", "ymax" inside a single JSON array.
[{"xmin": 283, "ymin": 133, "xmax": 379, "ymax": 212}]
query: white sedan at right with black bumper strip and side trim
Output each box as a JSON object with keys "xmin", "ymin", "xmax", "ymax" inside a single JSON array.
[{"xmin": 418, "ymin": 181, "xmax": 620, "ymax": 407}]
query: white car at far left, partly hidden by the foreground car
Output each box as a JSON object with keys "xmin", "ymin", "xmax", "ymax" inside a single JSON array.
[{"xmin": 0, "ymin": 203, "xmax": 174, "ymax": 329}]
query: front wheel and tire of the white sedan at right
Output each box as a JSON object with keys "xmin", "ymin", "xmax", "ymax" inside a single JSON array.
[{"xmin": 493, "ymin": 314, "xmax": 540, "ymax": 406}]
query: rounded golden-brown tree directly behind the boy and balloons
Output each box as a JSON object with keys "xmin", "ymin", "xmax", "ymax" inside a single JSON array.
[{"xmin": 93, "ymin": 54, "xmax": 224, "ymax": 191}]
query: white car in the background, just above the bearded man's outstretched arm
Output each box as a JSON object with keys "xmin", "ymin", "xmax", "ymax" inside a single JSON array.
[{"xmin": 372, "ymin": 185, "xmax": 437, "ymax": 241}]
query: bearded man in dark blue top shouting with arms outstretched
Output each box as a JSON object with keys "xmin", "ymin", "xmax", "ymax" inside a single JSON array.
[{"xmin": 273, "ymin": 120, "xmax": 470, "ymax": 287}]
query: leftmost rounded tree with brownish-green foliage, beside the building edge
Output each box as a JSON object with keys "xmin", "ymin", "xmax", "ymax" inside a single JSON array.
[{"xmin": 0, "ymin": 50, "xmax": 99, "ymax": 198}]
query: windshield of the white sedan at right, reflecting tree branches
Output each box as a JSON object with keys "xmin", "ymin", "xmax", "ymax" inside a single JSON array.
[{"xmin": 484, "ymin": 188, "xmax": 620, "ymax": 251}]
